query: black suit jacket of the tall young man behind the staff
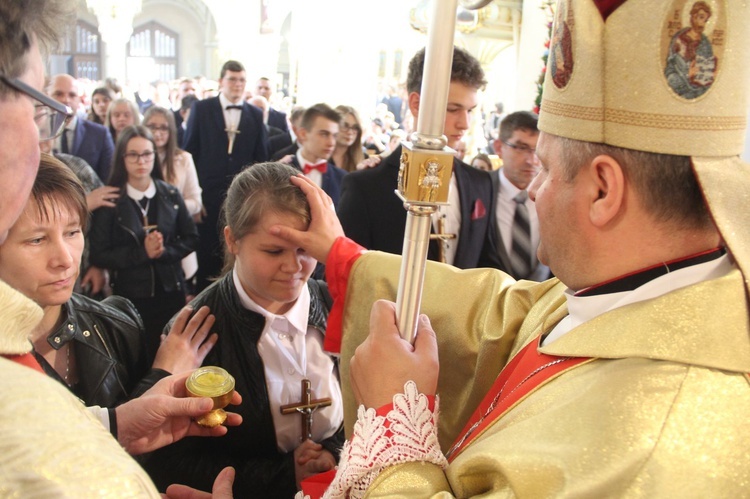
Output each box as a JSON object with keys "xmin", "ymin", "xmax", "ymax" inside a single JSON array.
[{"xmin": 336, "ymin": 146, "xmax": 501, "ymax": 269}]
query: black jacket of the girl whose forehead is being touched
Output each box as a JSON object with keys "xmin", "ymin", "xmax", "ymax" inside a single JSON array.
[{"xmin": 144, "ymin": 272, "xmax": 344, "ymax": 498}]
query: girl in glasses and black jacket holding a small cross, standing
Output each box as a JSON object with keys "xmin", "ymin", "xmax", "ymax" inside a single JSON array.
[{"xmin": 89, "ymin": 126, "xmax": 198, "ymax": 360}]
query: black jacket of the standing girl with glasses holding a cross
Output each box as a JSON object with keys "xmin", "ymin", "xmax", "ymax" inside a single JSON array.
[{"xmin": 89, "ymin": 180, "xmax": 198, "ymax": 298}]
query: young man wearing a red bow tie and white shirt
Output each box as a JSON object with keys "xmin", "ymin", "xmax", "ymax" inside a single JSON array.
[{"xmin": 291, "ymin": 104, "xmax": 346, "ymax": 205}]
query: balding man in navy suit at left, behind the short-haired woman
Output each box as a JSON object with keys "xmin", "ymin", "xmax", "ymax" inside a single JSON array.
[{"xmin": 48, "ymin": 74, "xmax": 115, "ymax": 183}]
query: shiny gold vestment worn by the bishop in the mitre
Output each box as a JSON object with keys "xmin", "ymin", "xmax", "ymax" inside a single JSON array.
[{"xmin": 341, "ymin": 253, "xmax": 750, "ymax": 498}]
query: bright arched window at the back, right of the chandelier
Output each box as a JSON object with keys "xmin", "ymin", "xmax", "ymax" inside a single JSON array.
[{"xmin": 128, "ymin": 22, "xmax": 179, "ymax": 81}]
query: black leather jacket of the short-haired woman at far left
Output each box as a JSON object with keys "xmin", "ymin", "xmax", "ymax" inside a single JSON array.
[{"xmin": 36, "ymin": 293, "xmax": 169, "ymax": 407}]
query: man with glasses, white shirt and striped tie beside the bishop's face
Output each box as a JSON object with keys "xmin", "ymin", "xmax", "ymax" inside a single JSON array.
[{"xmin": 490, "ymin": 111, "xmax": 549, "ymax": 281}]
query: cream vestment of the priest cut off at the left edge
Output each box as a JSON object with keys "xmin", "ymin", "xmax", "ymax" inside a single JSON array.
[{"xmin": 0, "ymin": 281, "xmax": 160, "ymax": 498}]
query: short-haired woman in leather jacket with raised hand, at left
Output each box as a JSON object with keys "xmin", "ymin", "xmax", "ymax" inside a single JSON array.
[{"xmin": 0, "ymin": 154, "xmax": 216, "ymax": 408}]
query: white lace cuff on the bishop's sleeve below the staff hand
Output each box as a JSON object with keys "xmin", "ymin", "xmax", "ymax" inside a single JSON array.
[{"xmin": 323, "ymin": 381, "xmax": 448, "ymax": 498}]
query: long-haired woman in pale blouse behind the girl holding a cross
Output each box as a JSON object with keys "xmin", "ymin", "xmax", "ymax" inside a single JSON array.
[{"xmin": 143, "ymin": 106, "xmax": 203, "ymax": 295}]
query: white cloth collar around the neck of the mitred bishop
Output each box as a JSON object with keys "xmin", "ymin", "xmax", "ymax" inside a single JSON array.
[{"xmin": 542, "ymin": 255, "xmax": 734, "ymax": 345}]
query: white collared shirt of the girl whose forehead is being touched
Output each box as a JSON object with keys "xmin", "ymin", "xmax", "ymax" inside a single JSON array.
[{"xmin": 232, "ymin": 268, "xmax": 344, "ymax": 452}]
